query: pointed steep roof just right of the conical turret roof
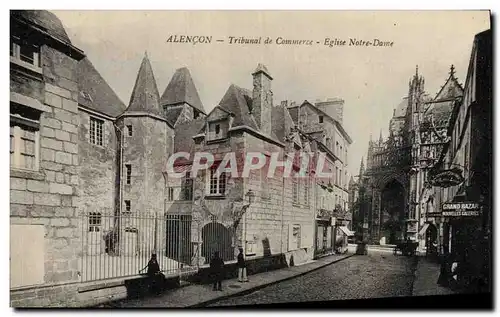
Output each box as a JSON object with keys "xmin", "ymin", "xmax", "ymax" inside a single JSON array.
[{"xmin": 160, "ymin": 67, "xmax": 206, "ymax": 114}]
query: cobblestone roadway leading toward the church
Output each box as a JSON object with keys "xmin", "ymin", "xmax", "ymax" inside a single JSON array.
[{"xmin": 210, "ymin": 252, "xmax": 416, "ymax": 307}]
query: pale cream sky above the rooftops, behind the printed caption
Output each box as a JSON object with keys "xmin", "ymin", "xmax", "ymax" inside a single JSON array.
[{"xmin": 53, "ymin": 11, "xmax": 490, "ymax": 175}]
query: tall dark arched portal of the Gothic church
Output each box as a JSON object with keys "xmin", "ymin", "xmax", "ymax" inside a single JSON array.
[{"xmin": 380, "ymin": 180, "xmax": 405, "ymax": 244}]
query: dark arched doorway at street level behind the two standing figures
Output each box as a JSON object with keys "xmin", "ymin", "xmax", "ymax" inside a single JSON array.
[{"xmin": 201, "ymin": 221, "xmax": 234, "ymax": 263}]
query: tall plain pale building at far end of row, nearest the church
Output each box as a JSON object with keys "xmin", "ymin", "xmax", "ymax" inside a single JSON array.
[{"xmin": 288, "ymin": 98, "xmax": 353, "ymax": 254}]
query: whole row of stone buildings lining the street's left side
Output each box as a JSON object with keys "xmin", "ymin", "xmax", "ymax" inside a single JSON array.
[{"xmin": 10, "ymin": 11, "xmax": 351, "ymax": 307}]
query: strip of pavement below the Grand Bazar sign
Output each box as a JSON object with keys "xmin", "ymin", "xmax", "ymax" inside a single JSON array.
[{"xmin": 412, "ymin": 257, "xmax": 456, "ymax": 296}]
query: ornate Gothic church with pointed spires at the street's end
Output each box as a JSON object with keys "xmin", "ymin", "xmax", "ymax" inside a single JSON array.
[{"xmin": 355, "ymin": 66, "xmax": 463, "ymax": 244}]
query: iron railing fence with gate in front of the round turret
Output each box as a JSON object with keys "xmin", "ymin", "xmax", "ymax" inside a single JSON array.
[{"xmin": 81, "ymin": 212, "xmax": 200, "ymax": 282}]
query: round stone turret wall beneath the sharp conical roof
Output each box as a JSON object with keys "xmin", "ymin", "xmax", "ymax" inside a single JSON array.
[{"xmin": 118, "ymin": 116, "xmax": 173, "ymax": 254}]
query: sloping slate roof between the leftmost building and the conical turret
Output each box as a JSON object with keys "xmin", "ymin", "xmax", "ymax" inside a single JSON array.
[{"xmin": 77, "ymin": 58, "xmax": 126, "ymax": 117}]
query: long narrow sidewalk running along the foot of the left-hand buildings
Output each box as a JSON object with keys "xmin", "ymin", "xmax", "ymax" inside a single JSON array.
[{"xmin": 99, "ymin": 253, "xmax": 353, "ymax": 308}]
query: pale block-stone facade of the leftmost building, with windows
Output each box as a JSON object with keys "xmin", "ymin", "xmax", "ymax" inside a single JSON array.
[{"xmin": 10, "ymin": 13, "xmax": 83, "ymax": 306}]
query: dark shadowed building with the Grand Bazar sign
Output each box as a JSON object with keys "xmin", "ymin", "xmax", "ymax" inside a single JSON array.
[{"xmin": 424, "ymin": 30, "xmax": 493, "ymax": 292}]
